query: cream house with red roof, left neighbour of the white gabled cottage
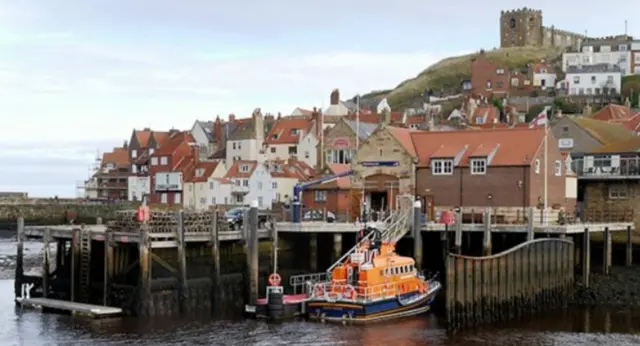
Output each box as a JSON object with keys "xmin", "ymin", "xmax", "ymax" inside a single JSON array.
[{"xmin": 183, "ymin": 161, "xmax": 227, "ymax": 210}]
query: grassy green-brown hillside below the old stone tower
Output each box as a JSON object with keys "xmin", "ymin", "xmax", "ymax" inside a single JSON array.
[{"xmin": 362, "ymin": 47, "xmax": 564, "ymax": 108}]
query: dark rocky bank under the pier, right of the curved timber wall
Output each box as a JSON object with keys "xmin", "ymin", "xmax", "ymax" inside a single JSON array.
[{"xmin": 571, "ymin": 265, "xmax": 640, "ymax": 308}]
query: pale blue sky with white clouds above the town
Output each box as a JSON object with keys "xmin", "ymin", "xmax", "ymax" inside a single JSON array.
[{"xmin": 0, "ymin": 0, "xmax": 640, "ymax": 197}]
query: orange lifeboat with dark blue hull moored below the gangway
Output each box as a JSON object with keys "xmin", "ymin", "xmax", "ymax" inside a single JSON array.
[{"xmin": 306, "ymin": 224, "xmax": 441, "ymax": 324}]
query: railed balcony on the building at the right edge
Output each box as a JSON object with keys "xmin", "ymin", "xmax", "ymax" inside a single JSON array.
[{"xmin": 571, "ymin": 155, "xmax": 640, "ymax": 180}]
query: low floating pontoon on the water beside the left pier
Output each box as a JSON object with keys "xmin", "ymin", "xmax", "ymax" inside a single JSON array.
[{"xmin": 16, "ymin": 298, "xmax": 122, "ymax": 318}]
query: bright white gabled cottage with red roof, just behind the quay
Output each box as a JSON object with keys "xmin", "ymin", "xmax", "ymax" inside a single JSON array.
[{"xmin": 220, "ymin": 160, "xmax": 276, "ymax": 209}]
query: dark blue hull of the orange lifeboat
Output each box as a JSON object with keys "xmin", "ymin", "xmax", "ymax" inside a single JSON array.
[{"xmin": 307, "ymin": 285, "xmax": 440, "ymax": 324}]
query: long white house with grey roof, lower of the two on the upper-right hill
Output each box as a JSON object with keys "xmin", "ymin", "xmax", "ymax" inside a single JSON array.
[{"xmin": 562, "ymin": 64, "xmax": 622, "ymax": 95}]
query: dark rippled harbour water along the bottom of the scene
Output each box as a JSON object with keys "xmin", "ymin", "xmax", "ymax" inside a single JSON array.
[{"xmin": 0, "ymin": 239, "xmax": 640, "ymax": 346}]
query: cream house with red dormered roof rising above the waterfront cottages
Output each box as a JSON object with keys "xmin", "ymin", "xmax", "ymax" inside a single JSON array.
[{"xmin": 264, "ymin": 118, "xmax": 318, "ymax": 166}]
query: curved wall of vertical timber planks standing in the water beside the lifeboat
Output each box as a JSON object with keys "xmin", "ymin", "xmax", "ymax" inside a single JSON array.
[{"xmin": 445, "ymin": 239, "xmax": 574, "ymax": 331}]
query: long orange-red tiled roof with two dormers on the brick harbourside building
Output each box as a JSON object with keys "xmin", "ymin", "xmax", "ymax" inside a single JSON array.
[{"xmin": 411, "ymin": 128, "xmax": 544, "ymax": 166}]
